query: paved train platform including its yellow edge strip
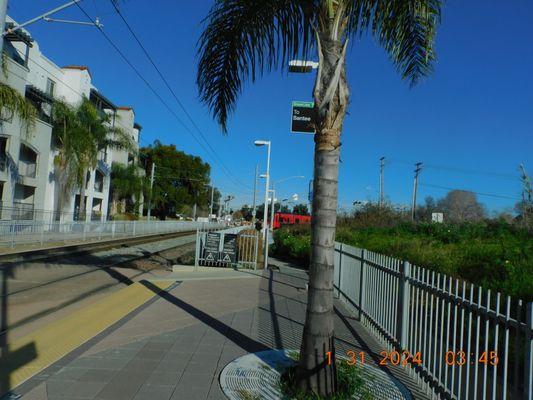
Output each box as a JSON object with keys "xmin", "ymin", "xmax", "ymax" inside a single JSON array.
[{"xmin": 0, "ymin": 264, "xmax": 425, "ymax": 400}]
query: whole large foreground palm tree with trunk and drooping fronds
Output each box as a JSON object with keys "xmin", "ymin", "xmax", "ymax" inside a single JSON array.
[{"xmin": 197, "ymin": 0, "xmax": 442, "ymax": 396}]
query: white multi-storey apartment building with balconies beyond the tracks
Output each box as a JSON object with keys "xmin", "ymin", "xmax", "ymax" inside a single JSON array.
[{"xmin": 0, "ymin": 17, "xmax": 144, "ymax": 220}]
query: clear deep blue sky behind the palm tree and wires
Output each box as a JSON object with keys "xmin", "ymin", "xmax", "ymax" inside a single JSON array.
[{"xmin": 9, "ymin": 0, "xmax": 533, "ymax": 210}]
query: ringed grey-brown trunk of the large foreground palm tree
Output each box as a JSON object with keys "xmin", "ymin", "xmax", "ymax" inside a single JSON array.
[{"xmin": 298, "ymin": 27, "xmax": 348, "ymax": 396}]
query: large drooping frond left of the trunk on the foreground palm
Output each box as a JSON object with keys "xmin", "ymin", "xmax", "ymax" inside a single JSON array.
[{"xmin": 197, "ymin": 0, "xmax": 314, "ymax": 132}]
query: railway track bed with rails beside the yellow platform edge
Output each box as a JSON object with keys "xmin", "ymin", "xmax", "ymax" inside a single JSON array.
[{"xmin": 0, "ymin": 231, "xmax": 200, "ymax": 347}]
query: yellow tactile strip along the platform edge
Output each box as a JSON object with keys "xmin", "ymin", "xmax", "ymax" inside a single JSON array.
[{"xmin": 0, "ymin": 281, "xmax": 175, "ymax": 396}]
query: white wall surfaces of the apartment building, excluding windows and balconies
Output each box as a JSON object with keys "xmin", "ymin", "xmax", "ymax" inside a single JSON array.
[{"xmin": 0, "ymin": 17, "xmax": 139, "ymax": 222}]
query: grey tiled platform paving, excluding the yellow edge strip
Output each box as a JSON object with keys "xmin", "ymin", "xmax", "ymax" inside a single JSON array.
[{"xmin": 2, "ymin": 267, "xmax": 424, "ymax": 400}]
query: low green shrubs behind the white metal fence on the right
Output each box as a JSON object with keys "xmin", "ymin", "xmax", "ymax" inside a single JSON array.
[{"xmin": 274, "ymin": 218, "xmax": 533, "ymax": 301}]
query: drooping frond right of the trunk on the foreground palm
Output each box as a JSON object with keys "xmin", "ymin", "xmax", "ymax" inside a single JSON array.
[{"xmin": 348, "ymin": 0, "xmax": 443, "ymax": 85}]
